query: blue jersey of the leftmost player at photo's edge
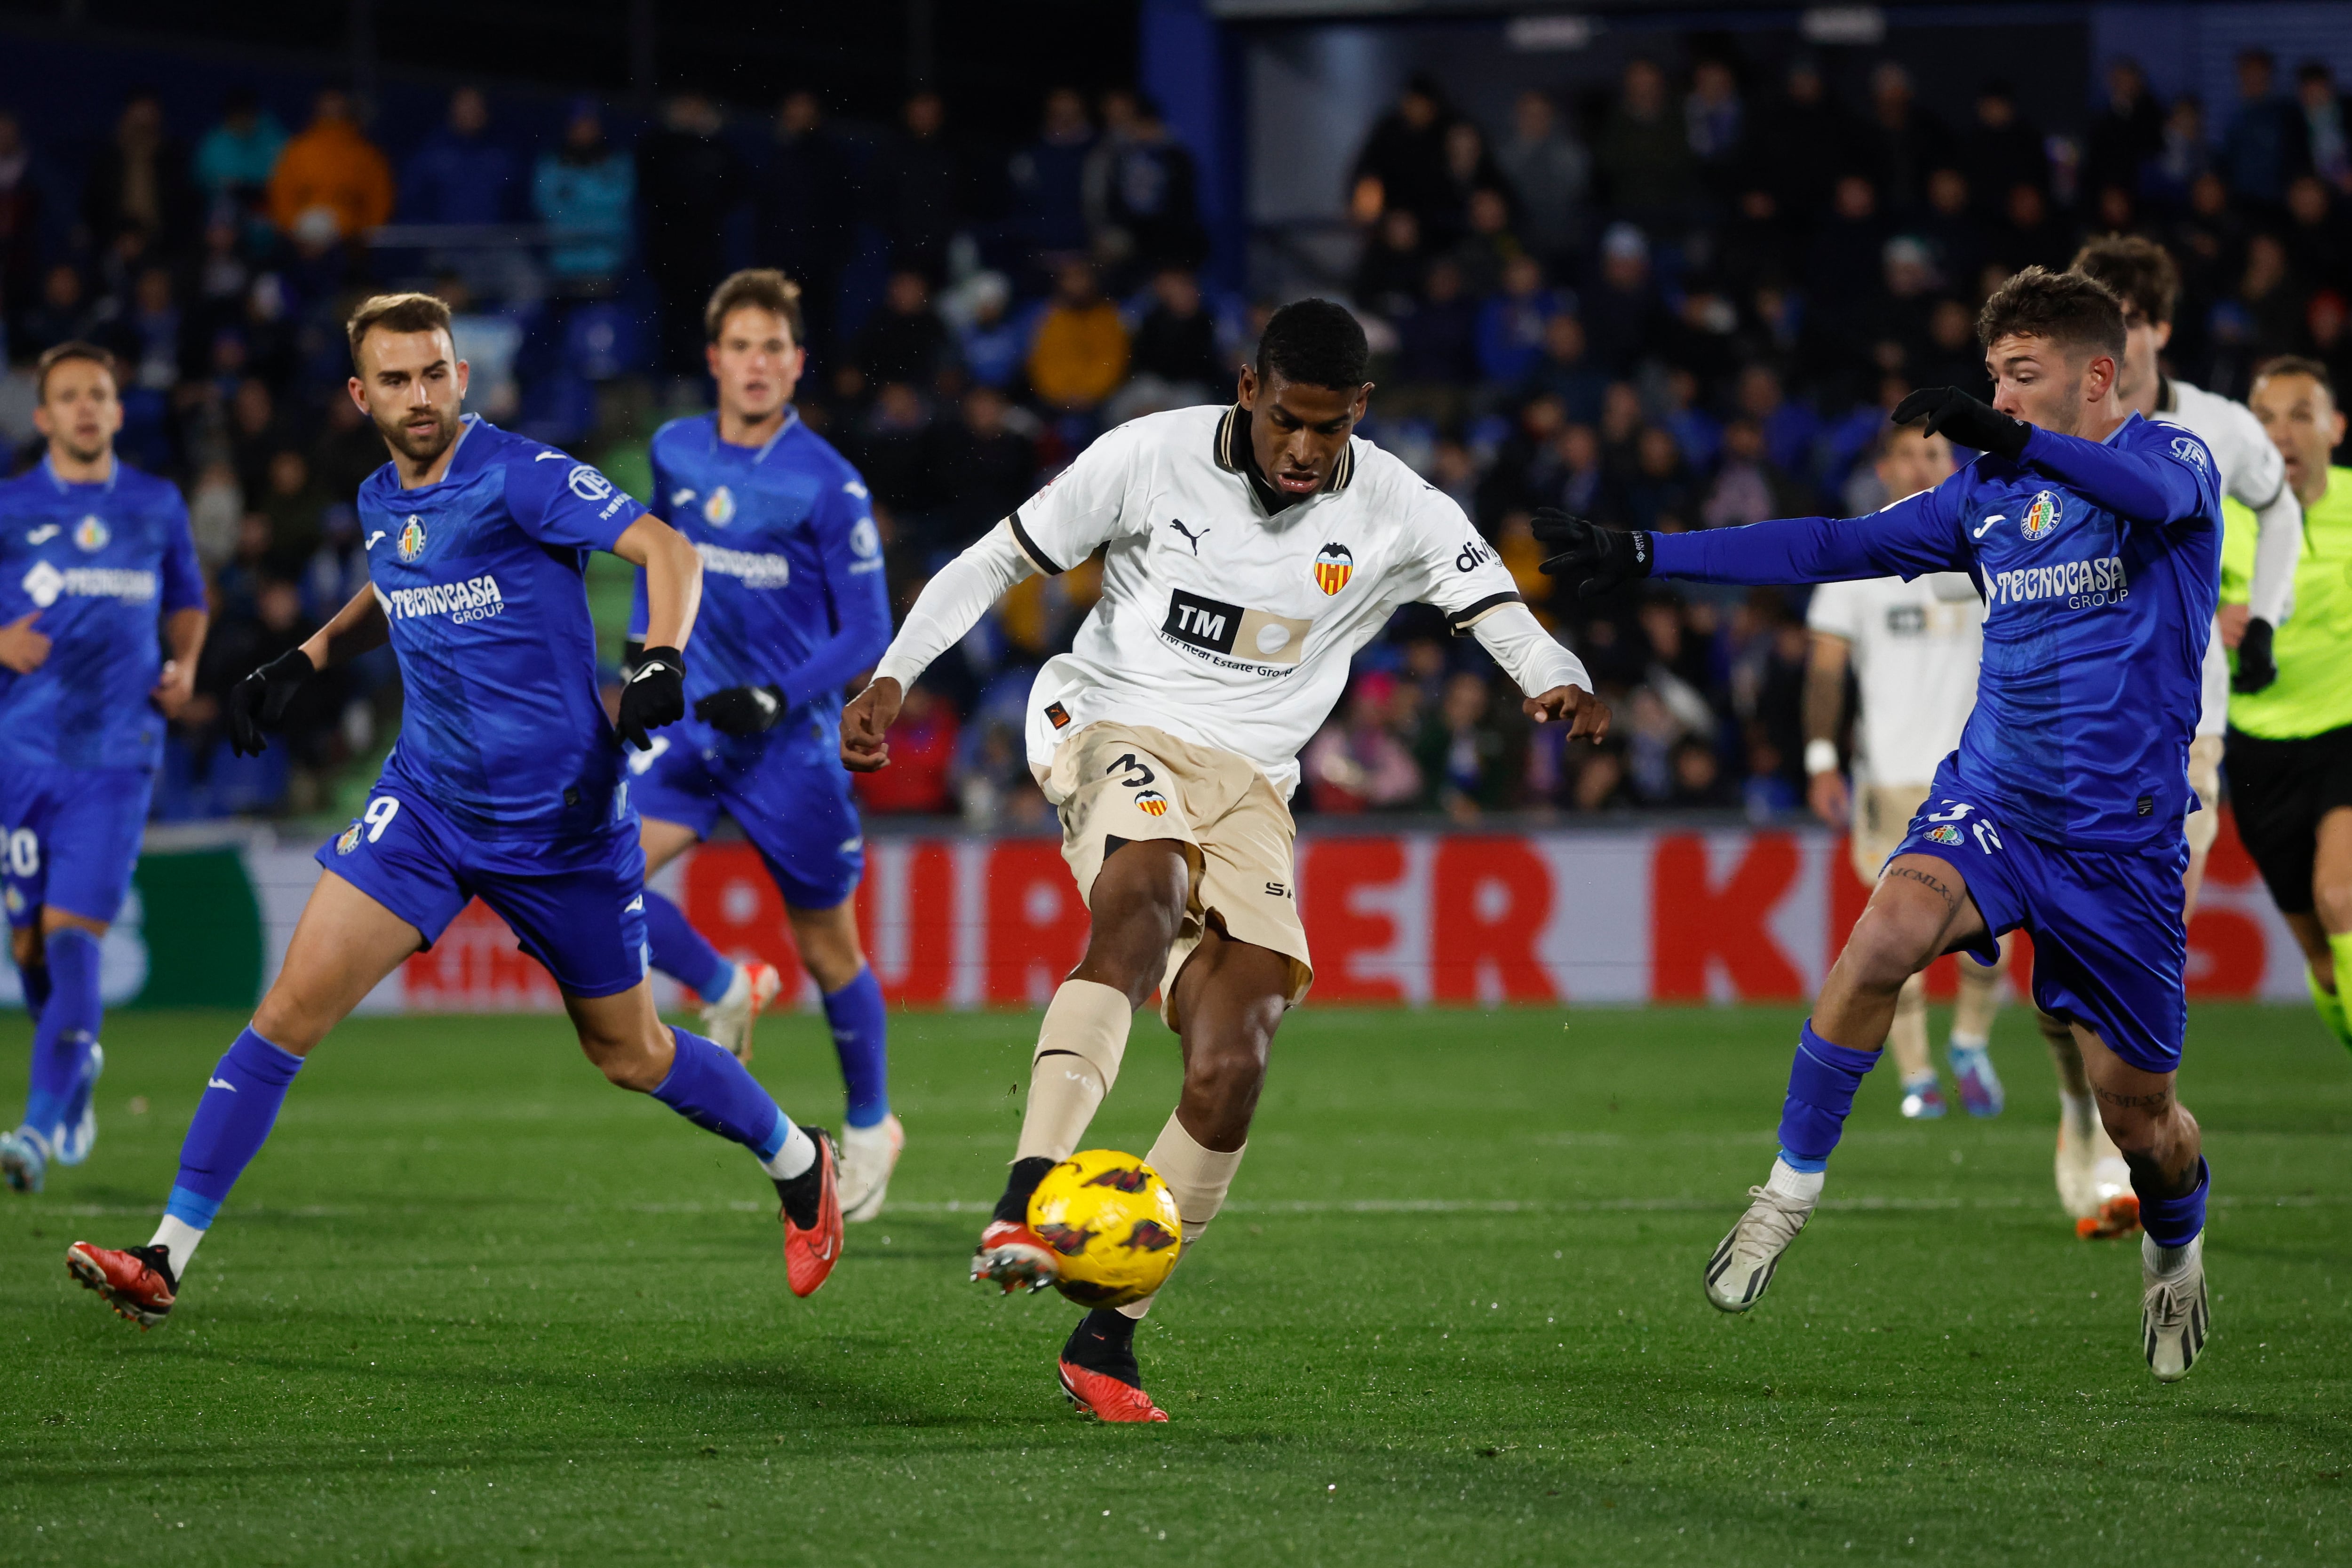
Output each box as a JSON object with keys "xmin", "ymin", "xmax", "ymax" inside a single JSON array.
[{"xmin": 0, "ymin": 458, "xmax": 205, "ymax": 771}]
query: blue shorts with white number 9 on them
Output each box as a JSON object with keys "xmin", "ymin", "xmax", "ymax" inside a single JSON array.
[{"xmin": 318, "ymin": 778, "xmax": 647, "ymax": 997}]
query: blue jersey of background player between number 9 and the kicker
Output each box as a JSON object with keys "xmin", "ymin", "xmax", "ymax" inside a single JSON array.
[{"xmin": 630, "ymin": 411, "xmax": 889, "ymax": 745}]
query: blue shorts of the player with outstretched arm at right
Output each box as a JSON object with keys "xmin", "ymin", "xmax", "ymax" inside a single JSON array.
[{"xmin": 1896, "ymin": 776, "xmax": 2190, "ymax": 1072}]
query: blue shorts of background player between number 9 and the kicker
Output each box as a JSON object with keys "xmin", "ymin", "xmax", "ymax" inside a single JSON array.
[{"xmin": 628, "ymin": 724, "xmax": 866, "ymax": 910}]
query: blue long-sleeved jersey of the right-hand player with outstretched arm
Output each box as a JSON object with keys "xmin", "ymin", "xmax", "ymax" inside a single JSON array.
[{"xmin": 1653, "ymin": 414, "xmax": 2220, "ymax": 849}]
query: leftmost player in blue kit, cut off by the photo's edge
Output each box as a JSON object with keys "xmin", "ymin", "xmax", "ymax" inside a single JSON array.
[{"xmin": 0, "ymin": 343, "xmax": 205, "ymax": 1192}]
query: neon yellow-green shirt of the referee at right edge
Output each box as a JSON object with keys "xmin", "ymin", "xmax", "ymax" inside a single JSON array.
[{"xmin": 2220, "ymin": 468, "xmax": 2352, "ymax": 740}]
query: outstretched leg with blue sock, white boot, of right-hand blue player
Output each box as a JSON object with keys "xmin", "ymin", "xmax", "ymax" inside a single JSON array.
[{"xmin": 1703, "ymin": 846, "xmax": 1990, "ymax": 1312}]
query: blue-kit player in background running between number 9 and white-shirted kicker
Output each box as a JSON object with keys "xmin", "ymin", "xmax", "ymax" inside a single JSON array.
[{"xmin": 628, "ymin": 268, "xmax": 906, "ymax": 1222}]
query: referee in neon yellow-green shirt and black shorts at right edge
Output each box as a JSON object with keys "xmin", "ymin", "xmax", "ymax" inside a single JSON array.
[{"xmin": 2220, "ymin": 358, "xmax": 2352, "ymax": 1049}]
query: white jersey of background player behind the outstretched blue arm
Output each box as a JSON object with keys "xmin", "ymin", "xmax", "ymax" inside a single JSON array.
[{"xmin": 1804, "ymin": 571, "xmax": 1985, "ymax": 785}]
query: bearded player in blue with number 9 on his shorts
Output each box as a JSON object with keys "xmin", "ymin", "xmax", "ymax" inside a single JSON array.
[{"xmin": 66, "ymin": 294, "xmax": 842, "ymax": 1326}]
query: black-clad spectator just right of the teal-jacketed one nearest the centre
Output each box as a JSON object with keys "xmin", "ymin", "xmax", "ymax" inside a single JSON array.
[{"xmin": 637, "ymin": 92, "xmax": 746, "ymax": 379}]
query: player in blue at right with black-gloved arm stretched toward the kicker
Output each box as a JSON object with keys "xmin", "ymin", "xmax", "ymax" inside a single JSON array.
[{"xmin": 1538, "ymin": 268, "xmax": 2220, "ymax": 1382}]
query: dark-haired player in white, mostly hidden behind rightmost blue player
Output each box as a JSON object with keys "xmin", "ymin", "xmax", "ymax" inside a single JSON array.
[{"xmin": 2042, "ymin": 235, "xmax": 2303, "ymax": 1239}]
